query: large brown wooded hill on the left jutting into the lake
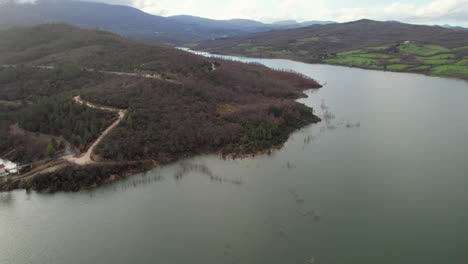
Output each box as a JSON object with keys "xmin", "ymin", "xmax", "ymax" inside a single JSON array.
[{"xmin": 0, "ymin": 24, "xmax": 320, "ymax": 167}]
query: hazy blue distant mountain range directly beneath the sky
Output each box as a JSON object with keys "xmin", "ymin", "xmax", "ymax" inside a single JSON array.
[{"xmin": 0, "ymin": 0, "xmax": 336, "ymax": 44}]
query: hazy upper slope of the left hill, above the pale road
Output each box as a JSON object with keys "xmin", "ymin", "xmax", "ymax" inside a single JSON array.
[{"xmin": 0, "ymin": 24, "xmax": 202, "ymax": 71}]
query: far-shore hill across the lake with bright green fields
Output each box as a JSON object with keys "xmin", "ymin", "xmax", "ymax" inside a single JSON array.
[{"xmin": 195, "ymin": 20, "xmax": 468, "ymax": 79}]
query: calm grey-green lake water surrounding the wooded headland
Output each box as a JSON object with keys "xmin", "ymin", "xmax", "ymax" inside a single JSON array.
[{"xmin": 0, "ymin": 53, "xmax": 468, "ymax": 264}]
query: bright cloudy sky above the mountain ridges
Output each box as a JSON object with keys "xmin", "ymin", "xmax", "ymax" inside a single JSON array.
[{"xmin": 12, "ymin": 0, "xmax": 468, "ymax": 27}]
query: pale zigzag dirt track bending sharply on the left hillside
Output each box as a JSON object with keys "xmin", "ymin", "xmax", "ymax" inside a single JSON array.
[{"xmin": 63, "ymin": 96, "xmax": 127, "ymax": 165}]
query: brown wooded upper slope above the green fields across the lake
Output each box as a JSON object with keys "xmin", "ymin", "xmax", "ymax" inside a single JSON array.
[{"xmin": 199, "ymin": 20, "xmax": 468, "ymax": 55}]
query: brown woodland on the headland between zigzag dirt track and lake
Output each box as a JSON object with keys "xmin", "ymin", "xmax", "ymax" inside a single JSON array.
[{"xmin": 82, "ymin": 61, "xmax": 318, "ymax": 162}]
